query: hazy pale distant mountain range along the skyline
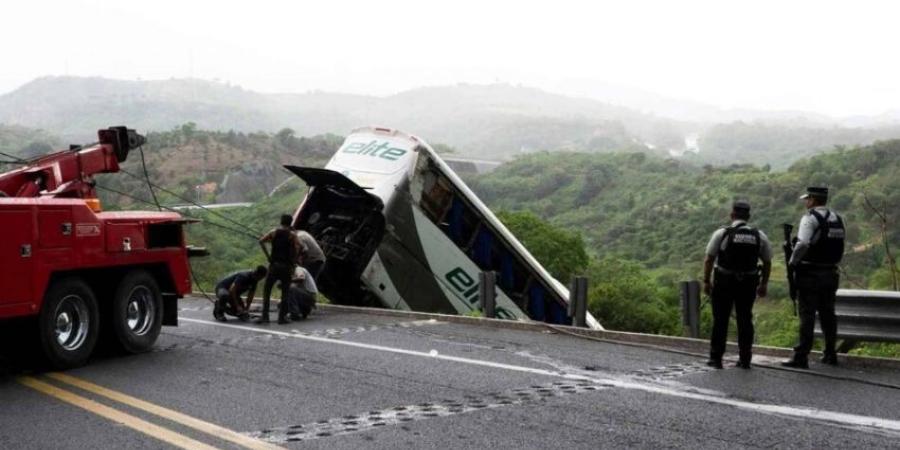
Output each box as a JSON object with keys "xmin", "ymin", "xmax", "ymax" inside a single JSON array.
[{"xmin": 0, "ymin": 77, "xmax": 900, "ymax": 170}]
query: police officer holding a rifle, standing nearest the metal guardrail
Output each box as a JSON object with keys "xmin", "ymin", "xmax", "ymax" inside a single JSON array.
[{"xmin": 781, "ymin": 187, "xmax": 846, "ymax": 369}]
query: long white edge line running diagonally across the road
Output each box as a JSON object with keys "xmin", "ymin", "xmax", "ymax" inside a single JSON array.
[{"xmin": 179, "ymin": 318, "xmax": 900, "ymax": 437}]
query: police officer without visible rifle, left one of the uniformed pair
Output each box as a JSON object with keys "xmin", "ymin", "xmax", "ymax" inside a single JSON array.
[{"xmin": 703, "ymin": 200, "xmax": 772, "ymax": 369}]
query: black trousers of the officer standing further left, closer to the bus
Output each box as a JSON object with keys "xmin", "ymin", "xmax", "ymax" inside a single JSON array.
[{"xmin": 709, "ymin": 272, "xmax": 759, "ymax": 362}]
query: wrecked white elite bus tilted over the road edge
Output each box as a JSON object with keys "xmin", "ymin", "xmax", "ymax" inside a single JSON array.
[{"xmin": 285, "ymin": 128, "xmax": 602, "ymax": 329}]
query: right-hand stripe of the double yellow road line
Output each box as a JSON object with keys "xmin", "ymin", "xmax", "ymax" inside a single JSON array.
[{"xmin": 47, "ymin": 373, "xmax": 282, "ymax": 450}]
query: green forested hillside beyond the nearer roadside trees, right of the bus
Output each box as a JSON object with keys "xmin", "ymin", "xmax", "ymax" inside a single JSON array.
[{"xmin": 471, "ymin": 141, "xmax": 900, "ymax": 284}]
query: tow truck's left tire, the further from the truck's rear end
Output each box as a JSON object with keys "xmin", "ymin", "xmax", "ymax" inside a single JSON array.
[{"xmin": 37, "ymin": 278, "xmax": 100, "ymax": 369}]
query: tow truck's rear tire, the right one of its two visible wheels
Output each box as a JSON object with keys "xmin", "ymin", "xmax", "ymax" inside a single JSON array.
[{"xmin": 109, "ymin": 270, "xmax": 163, "ymax": 353}]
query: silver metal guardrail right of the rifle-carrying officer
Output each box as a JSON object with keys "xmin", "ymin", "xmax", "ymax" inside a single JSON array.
[{"xmin": 816, "ymin": 289, "xmax": 900, "ymax": 353}]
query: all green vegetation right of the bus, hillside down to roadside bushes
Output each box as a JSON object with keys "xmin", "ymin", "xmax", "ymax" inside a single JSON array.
[{"xmin": 470, "ymin": 141, "xmax": 900, "ymax": 356}]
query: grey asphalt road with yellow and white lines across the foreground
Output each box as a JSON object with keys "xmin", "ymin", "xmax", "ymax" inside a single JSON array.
[{"xmin": 0, "ymin": 299, "xmax": 900, "ymax": 449}]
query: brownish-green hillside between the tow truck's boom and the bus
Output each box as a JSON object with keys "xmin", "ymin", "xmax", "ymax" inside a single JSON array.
[{"xmin": 91, "ymin": 123, "xmax": 342, "ymax": 206}]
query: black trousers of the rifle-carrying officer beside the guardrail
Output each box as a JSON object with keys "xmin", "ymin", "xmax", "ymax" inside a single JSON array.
[{"xmin": 794, "ymin": 267, "xmax": 840, "ymax": 357}]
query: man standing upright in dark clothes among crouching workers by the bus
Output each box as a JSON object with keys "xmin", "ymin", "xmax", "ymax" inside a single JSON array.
[{"xmin": 256, "ymin": 214, "xmax": 300, "ymax": 324}]
